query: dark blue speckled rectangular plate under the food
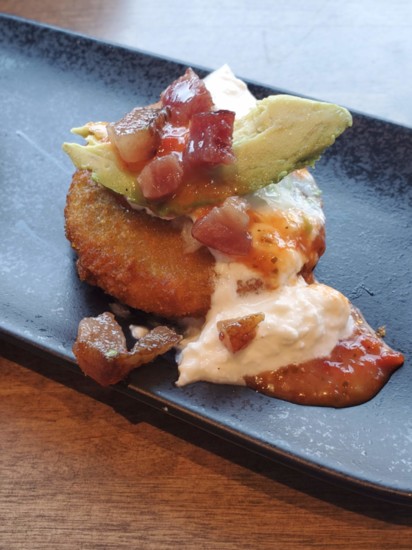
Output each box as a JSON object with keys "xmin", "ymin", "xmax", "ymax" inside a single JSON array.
[{"xmin": 0, "ymin": 16, "xmax": 412, "ymax": 503}]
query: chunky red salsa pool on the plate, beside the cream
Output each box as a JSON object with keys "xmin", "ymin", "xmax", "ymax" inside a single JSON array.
[{"xmin": 245, "ymin": 310, "xmax": 404, "ymax": 407}]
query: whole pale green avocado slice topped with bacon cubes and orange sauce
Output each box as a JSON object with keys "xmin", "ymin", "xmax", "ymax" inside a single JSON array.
[{"xmin": 63, "ymin": 95, "xmax": 352, "ymax": 217}]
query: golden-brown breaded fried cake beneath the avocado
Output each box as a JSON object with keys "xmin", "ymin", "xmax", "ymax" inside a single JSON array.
[{"xmin": 65, "ymin": 171, "xmax": 215, "ymax": 318}]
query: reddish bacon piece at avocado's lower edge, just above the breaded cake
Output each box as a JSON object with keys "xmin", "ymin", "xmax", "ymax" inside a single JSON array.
[{"xmin": 137, "ymin": 153, "xmax": 183, "ymax": 200}]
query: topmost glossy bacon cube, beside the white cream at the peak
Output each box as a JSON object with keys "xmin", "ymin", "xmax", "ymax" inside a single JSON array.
[{"xmin": 161, "ymin": 68, "xmax": 213, "ymax": 125}]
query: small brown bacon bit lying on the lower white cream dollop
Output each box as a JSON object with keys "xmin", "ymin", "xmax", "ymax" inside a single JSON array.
[{"xmin": 216, "ymin": 313, "xmax": 265, "ymax": 353}]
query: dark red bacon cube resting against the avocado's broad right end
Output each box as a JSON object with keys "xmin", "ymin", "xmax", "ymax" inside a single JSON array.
[{"xmin": 184, "ymin": 110, "xmax": 235, "ymax": 166}]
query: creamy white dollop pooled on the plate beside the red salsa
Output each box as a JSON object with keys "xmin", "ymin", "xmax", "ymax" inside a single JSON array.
[{"xmin": 177, "ymin": 270, "xmax": 353, "ymax": 386}]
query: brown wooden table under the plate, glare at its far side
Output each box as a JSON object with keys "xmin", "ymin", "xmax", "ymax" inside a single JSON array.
[{"xmin": 0, "ymin": 0, "xmax": 412, "ymax": 549}]
